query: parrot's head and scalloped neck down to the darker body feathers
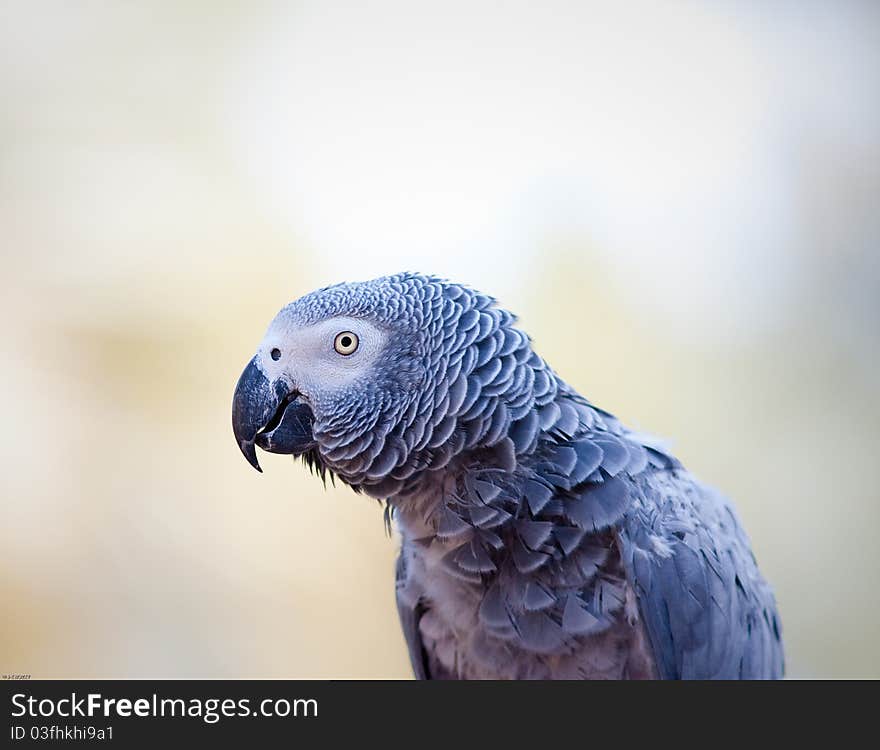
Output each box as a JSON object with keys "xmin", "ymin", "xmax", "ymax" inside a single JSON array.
[{"xmin": 232, "ymin": 274, "xmax": 536, "ymax": 496}]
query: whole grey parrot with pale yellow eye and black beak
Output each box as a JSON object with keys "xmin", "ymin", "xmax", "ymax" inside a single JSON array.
[{"xmin": 232, "ymin": 273, "xmax": 783, "ymax": 679}]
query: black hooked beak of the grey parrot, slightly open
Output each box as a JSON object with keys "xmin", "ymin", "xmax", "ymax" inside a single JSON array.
[{"xmin": 232, "ymin": 357, "xmax": 315, "ymax": 472}]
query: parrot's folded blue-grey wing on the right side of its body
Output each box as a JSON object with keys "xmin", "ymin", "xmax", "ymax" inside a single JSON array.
[{"xmin": 619, "ymin": 472, "xmax": 784, "ymax": 679}]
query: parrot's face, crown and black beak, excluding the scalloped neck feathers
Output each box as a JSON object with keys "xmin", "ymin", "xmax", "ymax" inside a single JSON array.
[{"xmin": 232, "ymin": 280, "xmax": 426, "ymax": 473}]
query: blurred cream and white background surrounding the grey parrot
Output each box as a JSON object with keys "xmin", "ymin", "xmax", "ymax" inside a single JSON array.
[{"xmin": 0, "ymin": 0, "xmax": 880, "ymax": 678}]
